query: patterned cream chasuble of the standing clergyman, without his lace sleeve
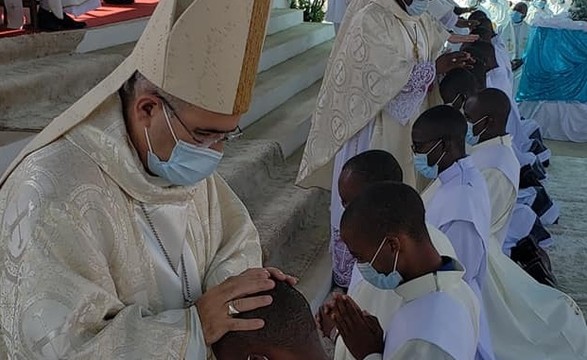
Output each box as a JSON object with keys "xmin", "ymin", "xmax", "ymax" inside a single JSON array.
[{"xmin": 297, "ymin": 0, "xmax": 448, "ymax": 189}]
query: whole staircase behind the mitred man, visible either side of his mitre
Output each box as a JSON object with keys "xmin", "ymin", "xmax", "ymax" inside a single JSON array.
[{"xmin": 0, "ymin": 0, "xmax": 334, "ymax": 309}]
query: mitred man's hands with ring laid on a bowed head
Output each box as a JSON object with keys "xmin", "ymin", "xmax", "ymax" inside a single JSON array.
[{"xmin": 194, "ymin": 267, "xmax": 298, "ymax": 346}]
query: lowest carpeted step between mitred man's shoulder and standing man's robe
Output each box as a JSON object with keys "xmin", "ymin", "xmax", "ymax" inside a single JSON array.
[{"xmin": 219, "ymin": 140, "xmax": 332, "ymax": 311}]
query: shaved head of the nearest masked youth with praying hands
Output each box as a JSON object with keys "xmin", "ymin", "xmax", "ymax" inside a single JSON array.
[{"xmin": 340, "ymin": 181, "xmax": 442, "ymax": 281}]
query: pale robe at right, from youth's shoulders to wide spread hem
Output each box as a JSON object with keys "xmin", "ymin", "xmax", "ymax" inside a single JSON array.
[{"xmin": 472, "ymin": 135, "xmax": 587, "ymax": 360}]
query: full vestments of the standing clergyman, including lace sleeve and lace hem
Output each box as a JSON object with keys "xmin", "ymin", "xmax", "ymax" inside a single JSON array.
[{"xmin": 310, "ymin": 0, "xmax": 444, "ymax": 287}]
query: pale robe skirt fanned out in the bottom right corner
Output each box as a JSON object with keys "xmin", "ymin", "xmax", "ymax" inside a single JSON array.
[{"xmin": 483, "ymin": 217, "xmax": 587, "ymax": 360}]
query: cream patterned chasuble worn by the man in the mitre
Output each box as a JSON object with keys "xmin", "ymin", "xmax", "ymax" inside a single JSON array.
[{"xmin": 0, "ymin": 95, "xmax": 261, "ymax": 359}]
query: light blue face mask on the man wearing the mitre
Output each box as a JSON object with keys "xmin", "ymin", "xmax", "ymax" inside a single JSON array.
[{"xmin": 145, "ymin": 106, "xmax": 222, "ymax": 186}]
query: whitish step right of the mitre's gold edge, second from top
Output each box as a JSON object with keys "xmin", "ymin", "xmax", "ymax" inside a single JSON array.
[{"xmin": 259, "ymin": 23, "xmax": 334, "ymax": 72}]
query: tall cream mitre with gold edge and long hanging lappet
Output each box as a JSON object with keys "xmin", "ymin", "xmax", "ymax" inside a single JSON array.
[{"xmin": 0, "ymin": 0, "xmax": 271, "ymax": 185}]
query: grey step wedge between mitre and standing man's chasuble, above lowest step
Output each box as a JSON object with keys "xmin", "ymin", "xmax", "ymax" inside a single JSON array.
[{"xmin": 244, "ymin": 79, "xmax": 322, "ymax": 158}]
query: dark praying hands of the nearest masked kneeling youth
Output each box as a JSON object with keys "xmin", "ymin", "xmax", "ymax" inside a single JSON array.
[{"xmin": 316, "ymin": 294, "xmax": 384, "ymax": 360}]
